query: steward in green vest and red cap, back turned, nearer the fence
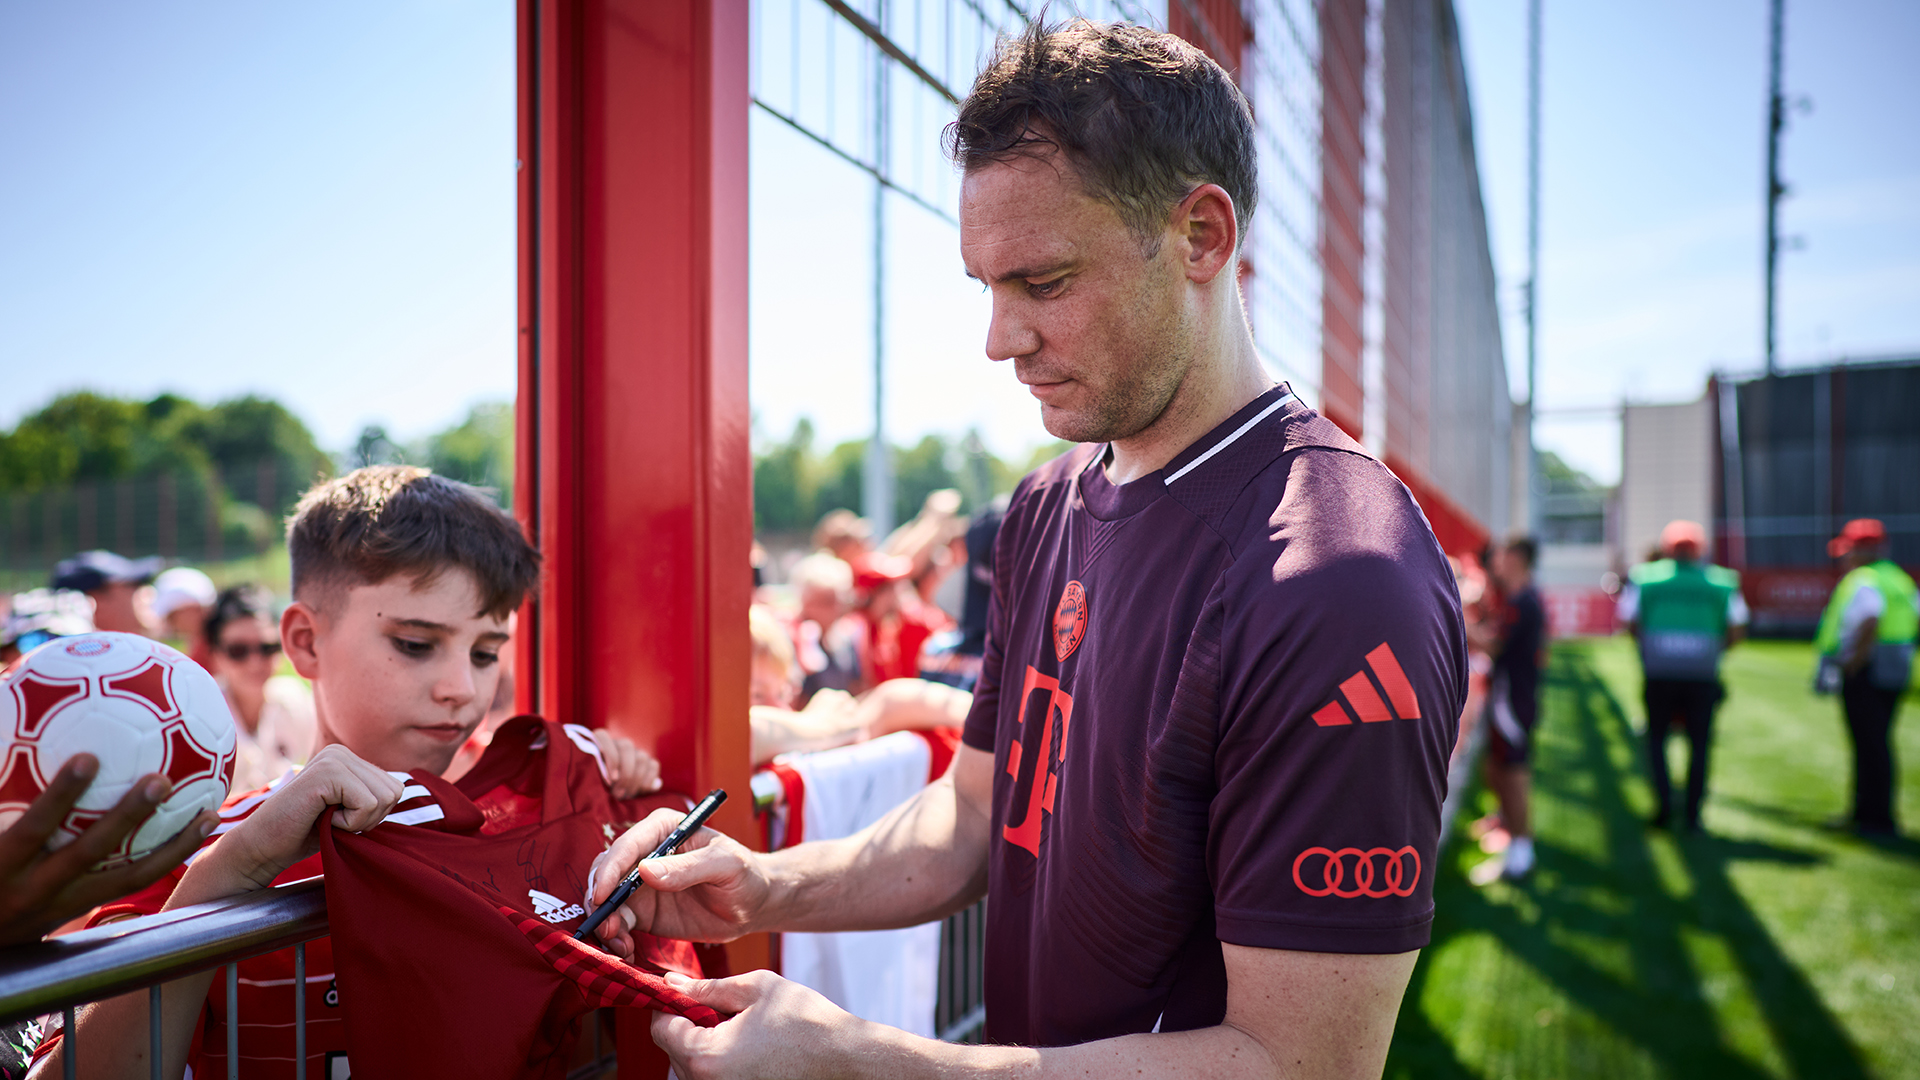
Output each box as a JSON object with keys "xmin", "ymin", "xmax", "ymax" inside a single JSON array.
[{"xmin": 1617, "ymin": 521, "xmax": 1747, "ymax": 832}]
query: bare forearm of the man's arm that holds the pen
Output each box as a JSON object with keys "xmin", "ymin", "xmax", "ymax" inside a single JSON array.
[{"xmin": 756, "ymin": 760, "xmax": 989, "ymax": 932}]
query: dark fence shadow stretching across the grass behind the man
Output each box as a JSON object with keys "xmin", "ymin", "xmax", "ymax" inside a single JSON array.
[{"xmin": 1388, "ymin": 644, "xmax": 1866, "ymax": 1078}]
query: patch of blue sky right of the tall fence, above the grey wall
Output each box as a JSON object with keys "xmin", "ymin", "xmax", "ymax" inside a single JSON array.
[{"xmin": 1459, "ymin": 0, "xmax": 1920, "ymax": 480}]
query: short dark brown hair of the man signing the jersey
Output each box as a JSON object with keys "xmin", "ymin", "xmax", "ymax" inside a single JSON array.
[{"xmin": 945, "ymin": 19, "xmax": 1260, "ymax": 258}]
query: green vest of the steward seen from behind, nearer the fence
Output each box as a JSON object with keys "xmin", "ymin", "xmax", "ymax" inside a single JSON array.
[{"xmin": 1626, "ymin": 559, "xmax": 1740, "ymax": 680}]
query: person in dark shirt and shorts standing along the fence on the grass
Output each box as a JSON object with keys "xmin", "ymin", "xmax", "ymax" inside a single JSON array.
[{"xmin": 1467, "ymin": 536, "xmax": 1548, "ymax": 880}]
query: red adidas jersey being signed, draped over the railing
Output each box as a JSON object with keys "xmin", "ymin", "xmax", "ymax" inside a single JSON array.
[{"xmin": 321, "ymin": 717, "xmax": 720, "ymax": 1080}]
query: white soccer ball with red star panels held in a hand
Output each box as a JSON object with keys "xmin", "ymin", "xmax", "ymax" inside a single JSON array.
[{"xmin": 0, "ymin": 632, "xmax": 234, "ymax": 865}]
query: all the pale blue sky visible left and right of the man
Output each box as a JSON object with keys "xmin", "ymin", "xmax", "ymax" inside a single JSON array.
[{"xmin": 0, "ymin": 0, "xmax": 1920, "ymax": 479}]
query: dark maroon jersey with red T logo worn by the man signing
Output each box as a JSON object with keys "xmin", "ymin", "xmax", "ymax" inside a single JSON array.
[{"xmin": 966, "ymin": 386, "xmax": 1467, "ymax": 1045}]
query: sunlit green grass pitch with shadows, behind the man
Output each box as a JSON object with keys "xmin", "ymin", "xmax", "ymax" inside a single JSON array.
[{"xmin": 1386, "ymin": 638, "xmax": 1920, "ymax": 1080}]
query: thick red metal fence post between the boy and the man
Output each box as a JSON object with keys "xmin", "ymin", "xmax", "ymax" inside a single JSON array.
[{"xmin": 515, "ymin": 0, "xmax": 766, "ymax": 1076}]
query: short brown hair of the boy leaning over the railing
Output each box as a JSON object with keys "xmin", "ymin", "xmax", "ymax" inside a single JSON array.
[{"xmin": 286, "ymin": 465, "xmax": 540, "ymax": 619}]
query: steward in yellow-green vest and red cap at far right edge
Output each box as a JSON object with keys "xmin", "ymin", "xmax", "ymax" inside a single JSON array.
[{"xmin": 1814, "ymin": 517, "xmax": 1920, "ymax": 836}]
